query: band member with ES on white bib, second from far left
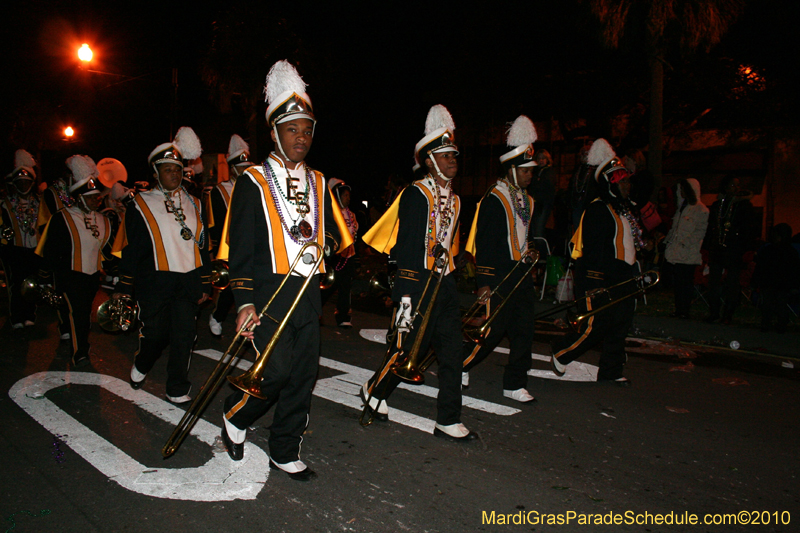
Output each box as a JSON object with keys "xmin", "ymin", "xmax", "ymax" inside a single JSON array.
[{"xmin": 36, "ymin": 155, "xmax": 111, "ymax": 367}]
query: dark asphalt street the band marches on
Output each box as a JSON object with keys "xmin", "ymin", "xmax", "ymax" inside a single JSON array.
[{"xmin": 0, "ymin": 296, "xmax": 800, "ymax": 533}]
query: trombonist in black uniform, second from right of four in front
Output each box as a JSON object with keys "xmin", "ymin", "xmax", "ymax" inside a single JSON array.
[{"xmin": 462, "ymin": 115, "xmax": 536, "ymax": 403}]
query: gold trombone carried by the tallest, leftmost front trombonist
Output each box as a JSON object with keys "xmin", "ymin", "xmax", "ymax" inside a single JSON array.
[{"xmin": 161, "ymin": 242, "xmax": 325, "ymax": 458}]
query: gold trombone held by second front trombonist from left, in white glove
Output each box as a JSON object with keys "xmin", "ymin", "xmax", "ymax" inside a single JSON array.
[{"xmin": 358, "ymin": 247, "xmax": 450, "ymax": 427}]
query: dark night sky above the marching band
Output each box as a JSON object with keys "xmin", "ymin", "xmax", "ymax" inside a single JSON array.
[{"xmin": 0, "ymin": 0, "xmax": 800, "ymax": 197}]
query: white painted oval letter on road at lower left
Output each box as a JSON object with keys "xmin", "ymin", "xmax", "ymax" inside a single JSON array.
[{"xmin": 8, "ymin": 372, "xmax": 269, "ymax": 501}]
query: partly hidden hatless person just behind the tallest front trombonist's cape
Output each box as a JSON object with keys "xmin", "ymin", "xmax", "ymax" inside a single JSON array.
[{"xmin": 322, "ymin": 180, "xmax": 358, "ymax": 328}]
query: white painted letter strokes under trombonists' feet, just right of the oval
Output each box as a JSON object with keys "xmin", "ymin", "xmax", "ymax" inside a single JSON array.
[{"xmin": 195, "ymin": 348, "xmax": 520, "ymax": 433}]
